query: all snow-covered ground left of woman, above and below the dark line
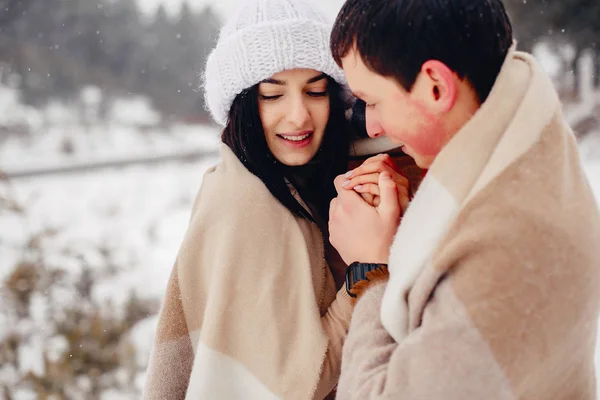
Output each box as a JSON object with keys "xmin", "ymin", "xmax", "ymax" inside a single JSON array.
[{"xmin": 0, "ymin": 86, "xmax": 225, "ymax": 400}]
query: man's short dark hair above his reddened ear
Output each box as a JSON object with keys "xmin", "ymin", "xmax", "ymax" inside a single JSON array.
[{"xmin": 331, "ymin": 0, "xmax": 513, "ymax": 102}]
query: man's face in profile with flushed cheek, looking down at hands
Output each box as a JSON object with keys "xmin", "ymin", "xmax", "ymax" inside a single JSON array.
[{"xmin": 342, "ymin": 49, "xmax": 449, "ymax": 169}]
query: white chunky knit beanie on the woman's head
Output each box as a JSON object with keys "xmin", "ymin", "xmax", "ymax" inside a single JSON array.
[{"xmin": 204, "ymin": 0, "xmax": 345, "ymax": 126}]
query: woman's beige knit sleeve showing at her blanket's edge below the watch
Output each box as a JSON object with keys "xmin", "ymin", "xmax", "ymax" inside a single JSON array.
[{"xmin": 314, "ymin": 287, "xmax": 353, "ymax": 400}]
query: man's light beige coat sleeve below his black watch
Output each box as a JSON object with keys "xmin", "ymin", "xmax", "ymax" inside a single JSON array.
[{"xmin": 338, "ymin": 280, "xmax": 523, "ymax": 400}]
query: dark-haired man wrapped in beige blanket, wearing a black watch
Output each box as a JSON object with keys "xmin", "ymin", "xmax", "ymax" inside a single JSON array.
[{"xmin": 330, "ymin": 0, "xmax": 600, "ymax": 400}]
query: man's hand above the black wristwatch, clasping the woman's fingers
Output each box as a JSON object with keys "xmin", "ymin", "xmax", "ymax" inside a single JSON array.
[{"xmin": 329, "ymin": 171, "xmax": 401, "ymax": 265}]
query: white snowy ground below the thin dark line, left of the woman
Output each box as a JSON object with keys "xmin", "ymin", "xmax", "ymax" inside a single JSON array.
[{"xmin": 0, "ymin": 154, "xmax": 216, "ymax": 394}]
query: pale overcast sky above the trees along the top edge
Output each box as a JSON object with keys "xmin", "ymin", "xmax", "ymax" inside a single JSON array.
[{"xmin": 137, "ymin": 0, "xmax": 344, "ymax": 20}]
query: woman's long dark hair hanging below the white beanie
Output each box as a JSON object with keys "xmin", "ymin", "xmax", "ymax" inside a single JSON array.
[{"xmin": 221, "ymin": 77, "xmax": 351, "ymax": 222}]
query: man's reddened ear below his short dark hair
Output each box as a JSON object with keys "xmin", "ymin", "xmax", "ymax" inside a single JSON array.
[{"xmin": 421, "ymin": 60, "xmax": 458, "ymax": 113}]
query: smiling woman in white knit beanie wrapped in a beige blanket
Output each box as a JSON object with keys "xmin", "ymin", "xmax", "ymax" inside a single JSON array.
[{"xmin": 144, "ymin": 0, "xmax": 370, "ymax": 400}]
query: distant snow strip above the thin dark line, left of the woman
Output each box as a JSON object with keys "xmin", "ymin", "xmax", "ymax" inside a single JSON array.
[{"xmin": 0, "ymin": 85, "xmax": 218, "ymax": 171}]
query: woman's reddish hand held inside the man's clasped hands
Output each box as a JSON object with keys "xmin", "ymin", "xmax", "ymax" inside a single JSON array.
[{"xmin": 342, "ymin": 154, "xmax": 411, "ymax": 214}]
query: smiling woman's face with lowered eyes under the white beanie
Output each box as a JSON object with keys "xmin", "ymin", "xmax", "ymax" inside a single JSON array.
[{"xmin": 258, "ymin": 69, "xmax": 329, "ymax": 167}]
